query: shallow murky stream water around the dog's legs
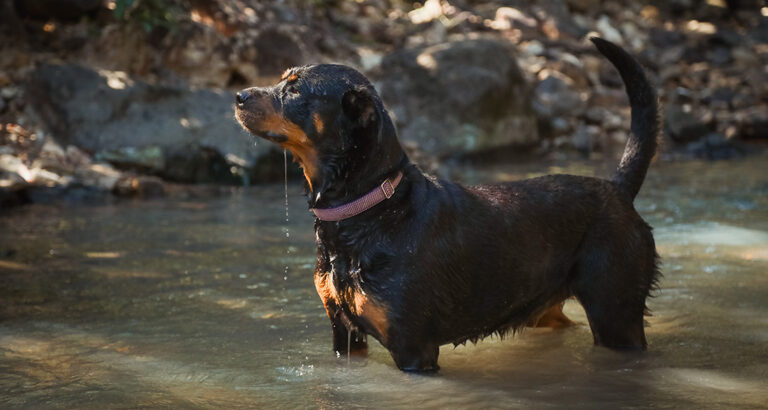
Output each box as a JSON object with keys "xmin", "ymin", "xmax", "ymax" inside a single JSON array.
[{"xmin": 0, "ymin": 158, "xmax": 768, "ymax": 409}]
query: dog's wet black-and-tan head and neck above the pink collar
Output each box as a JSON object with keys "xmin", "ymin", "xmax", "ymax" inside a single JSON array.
[{"xmin": 236, "ymin": 64, "xmax": 404, "ymax": 205}]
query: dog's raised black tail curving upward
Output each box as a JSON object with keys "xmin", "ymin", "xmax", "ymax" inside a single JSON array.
[{"xmin": 590, "ymin": 37, "xmax": 661, "ymax": 199}]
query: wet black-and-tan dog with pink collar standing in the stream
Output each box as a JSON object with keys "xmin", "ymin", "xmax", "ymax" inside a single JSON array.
[{"xmin": 235, "ymin": 38, "xmax": 660, "ymax": 372}]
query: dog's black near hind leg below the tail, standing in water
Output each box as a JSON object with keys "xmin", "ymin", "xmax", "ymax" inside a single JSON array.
[{"xmin": 571, "ymin": 227, "xmax": 657, "ymax": 350}]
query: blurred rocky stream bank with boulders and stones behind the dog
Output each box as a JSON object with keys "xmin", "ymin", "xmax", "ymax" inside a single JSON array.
[{"xmin": 0, "ymin": 0, "xmax": 768, "ymax": 206}]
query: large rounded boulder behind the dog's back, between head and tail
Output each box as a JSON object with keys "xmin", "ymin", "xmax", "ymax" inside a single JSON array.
[{"xmin": 372, "ymin": 39, "xmax": 538, "ymax": 157}]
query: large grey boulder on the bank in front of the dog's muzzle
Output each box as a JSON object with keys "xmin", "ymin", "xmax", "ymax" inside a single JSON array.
[{"xmin": 26, "ymin": 65, "xmax": 273, "ymax": 183}]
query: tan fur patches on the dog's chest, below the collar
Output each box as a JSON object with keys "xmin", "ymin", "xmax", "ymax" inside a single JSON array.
[{"xmin": 315, "ymin": 272, "xmax": 389, "ymax": 343}]
